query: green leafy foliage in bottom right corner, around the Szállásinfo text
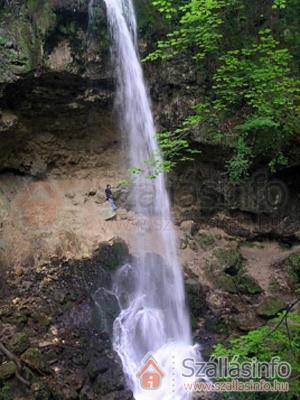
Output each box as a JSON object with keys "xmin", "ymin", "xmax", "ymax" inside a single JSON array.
[{"xmin": 214, "ymin": 312, "xmax": 300, "ymax": 400}]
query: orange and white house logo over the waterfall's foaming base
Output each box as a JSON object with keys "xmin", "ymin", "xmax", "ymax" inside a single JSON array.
[{"xmin": 137, "ymin": 355, "xmax": 165, "ymax": 390}]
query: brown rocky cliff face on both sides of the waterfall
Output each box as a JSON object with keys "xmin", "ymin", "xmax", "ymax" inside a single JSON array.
[{"xmin": 0, "ymin": 0, "xmax": 300, "ymax": 400}]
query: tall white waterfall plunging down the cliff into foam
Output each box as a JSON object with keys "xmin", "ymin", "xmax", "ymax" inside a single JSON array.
[{"xmin": 94, "ymin": 0, "xmax": 202, "ymax": 400}]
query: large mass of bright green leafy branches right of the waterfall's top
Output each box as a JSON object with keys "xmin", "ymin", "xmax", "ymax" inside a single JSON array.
[{"xmin": 146, "ymin": 0, "xmax": 300, "ymax": 181}]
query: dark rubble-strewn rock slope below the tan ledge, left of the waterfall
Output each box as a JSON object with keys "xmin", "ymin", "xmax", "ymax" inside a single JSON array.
[{"xmin": 0, "ymin": 239, "xmax": 132, "ymax": 400}]
